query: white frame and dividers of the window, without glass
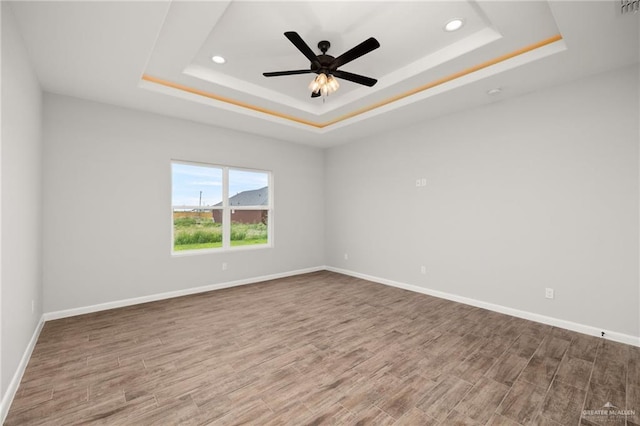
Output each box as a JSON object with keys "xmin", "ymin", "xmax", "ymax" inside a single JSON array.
[{"xmin": 170, "ymin": 160, "xmax": 274, "ymax": 256}]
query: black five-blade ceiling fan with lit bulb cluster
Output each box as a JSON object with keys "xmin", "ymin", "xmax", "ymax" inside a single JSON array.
[{"xmin": 262, "ymin": 31, "xmax": 380, "ymax": 98}]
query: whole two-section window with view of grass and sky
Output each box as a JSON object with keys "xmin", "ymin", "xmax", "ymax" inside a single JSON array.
[{"xmin": 171, "ymin": 161, "xmax": 273, "ymax": 253}]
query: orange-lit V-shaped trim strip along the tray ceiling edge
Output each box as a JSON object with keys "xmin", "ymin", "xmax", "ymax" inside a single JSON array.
[{"xmin": 141, "ymin": 34, "xmax": 563, "ymax": 129}]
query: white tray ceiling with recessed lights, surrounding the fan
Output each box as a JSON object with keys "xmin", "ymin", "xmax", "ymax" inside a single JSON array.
[{"xmin": 12, "ymin": 0, "xmax": 640, "ymax": 147}]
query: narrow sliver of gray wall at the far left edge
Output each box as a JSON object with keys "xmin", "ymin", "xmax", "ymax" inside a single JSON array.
[{"xmin": 0, "ymin": 2, "xmax": 42, "ymax": 396}]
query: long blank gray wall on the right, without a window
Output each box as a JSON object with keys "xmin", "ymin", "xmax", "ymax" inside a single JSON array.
[{"xmin": 325, "ymin": 67, "xmax": 640, "ymax": 336}]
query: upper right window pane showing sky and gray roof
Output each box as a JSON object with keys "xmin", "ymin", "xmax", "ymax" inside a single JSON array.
[{"xmin": 229, "ymin": 169, "xmax": 269, "ymax": 206}]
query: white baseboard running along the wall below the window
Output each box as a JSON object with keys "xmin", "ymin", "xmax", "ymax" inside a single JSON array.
[{"xmin": 43, "ymin": 266, "xmax": 325, "ymax": 321}]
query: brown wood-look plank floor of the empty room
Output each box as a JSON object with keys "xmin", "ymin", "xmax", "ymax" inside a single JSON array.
[{"xmin": 6, "ymin": 272, "xmax": 640, "ymax": 425}]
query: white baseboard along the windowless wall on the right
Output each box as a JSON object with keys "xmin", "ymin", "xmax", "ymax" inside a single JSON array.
[{"xmin": 325, "ymin": 266, "xmax": 640, "ymax": 347}]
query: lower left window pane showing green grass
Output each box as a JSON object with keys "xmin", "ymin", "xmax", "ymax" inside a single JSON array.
[{"xmin": 173, "ymin": 209, "xmax": 222, "ymax": 251}]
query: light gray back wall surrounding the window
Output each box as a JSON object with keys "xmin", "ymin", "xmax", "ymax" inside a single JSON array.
[{"xmin": 44, "ymin": 94, "xmax": 324, "ymax": 312}]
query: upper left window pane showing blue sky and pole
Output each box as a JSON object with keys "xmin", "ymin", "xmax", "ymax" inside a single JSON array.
[{"xmin": 171, "ymin": 163, "xmax": 222, "ymax": 209}]
